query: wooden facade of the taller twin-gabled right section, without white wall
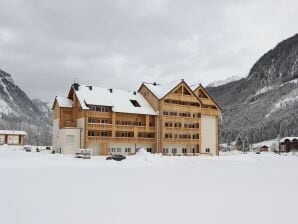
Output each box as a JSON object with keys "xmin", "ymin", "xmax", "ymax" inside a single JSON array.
[{"xmin": 139, "ymin": 80, "xmax": 221, "ymax": 155}]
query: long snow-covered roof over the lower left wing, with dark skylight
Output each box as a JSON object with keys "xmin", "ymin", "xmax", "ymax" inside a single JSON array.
[{"xmin": 75, "ymin": 85, "xmax": 156, "ymax": 115}]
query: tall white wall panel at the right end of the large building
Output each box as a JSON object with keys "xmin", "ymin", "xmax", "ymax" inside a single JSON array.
[{"xmin": 200, "ymin": 115, "xmax": 217, "ymax": 155}]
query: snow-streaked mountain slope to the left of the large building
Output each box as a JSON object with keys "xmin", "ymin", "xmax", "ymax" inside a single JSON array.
[{"xmin": 0, "ymin": 70, "xmax": 52, "ymax": 144}]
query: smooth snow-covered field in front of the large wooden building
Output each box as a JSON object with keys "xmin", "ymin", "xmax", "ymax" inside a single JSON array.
[{"xmin": 0, "ymin": 147, "xmax": 298, "ymax": 224}]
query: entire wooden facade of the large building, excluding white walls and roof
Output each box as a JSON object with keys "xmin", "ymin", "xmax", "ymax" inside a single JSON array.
[{"xmin": 53, "ymin": 81, "xmax": 221, "ymax": 155}]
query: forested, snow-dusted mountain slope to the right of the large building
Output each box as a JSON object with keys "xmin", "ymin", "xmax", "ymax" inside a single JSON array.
[{"xmin": 207, "ymin": 34, "xmax": 298, "ymax": 142}]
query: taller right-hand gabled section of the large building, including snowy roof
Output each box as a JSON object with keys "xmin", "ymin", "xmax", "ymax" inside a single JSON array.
[{"xmin": 139, "ymin": 80, "xmax": 221, "ymax": 155}]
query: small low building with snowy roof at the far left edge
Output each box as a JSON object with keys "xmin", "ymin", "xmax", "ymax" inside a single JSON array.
[{"xmin": 0, "ymin": 130, "xmax": 27, "ymax": 145}]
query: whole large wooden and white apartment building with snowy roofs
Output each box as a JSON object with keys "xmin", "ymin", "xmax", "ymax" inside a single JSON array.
[{"xmin": 53, "ymin": 80, "xmax": 221, "ymax": 155}]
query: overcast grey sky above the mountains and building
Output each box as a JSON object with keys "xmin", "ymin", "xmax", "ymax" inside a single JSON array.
[{"xmin": 0, "ymin": 0, "xmax": 298, "ymax": 101}]
